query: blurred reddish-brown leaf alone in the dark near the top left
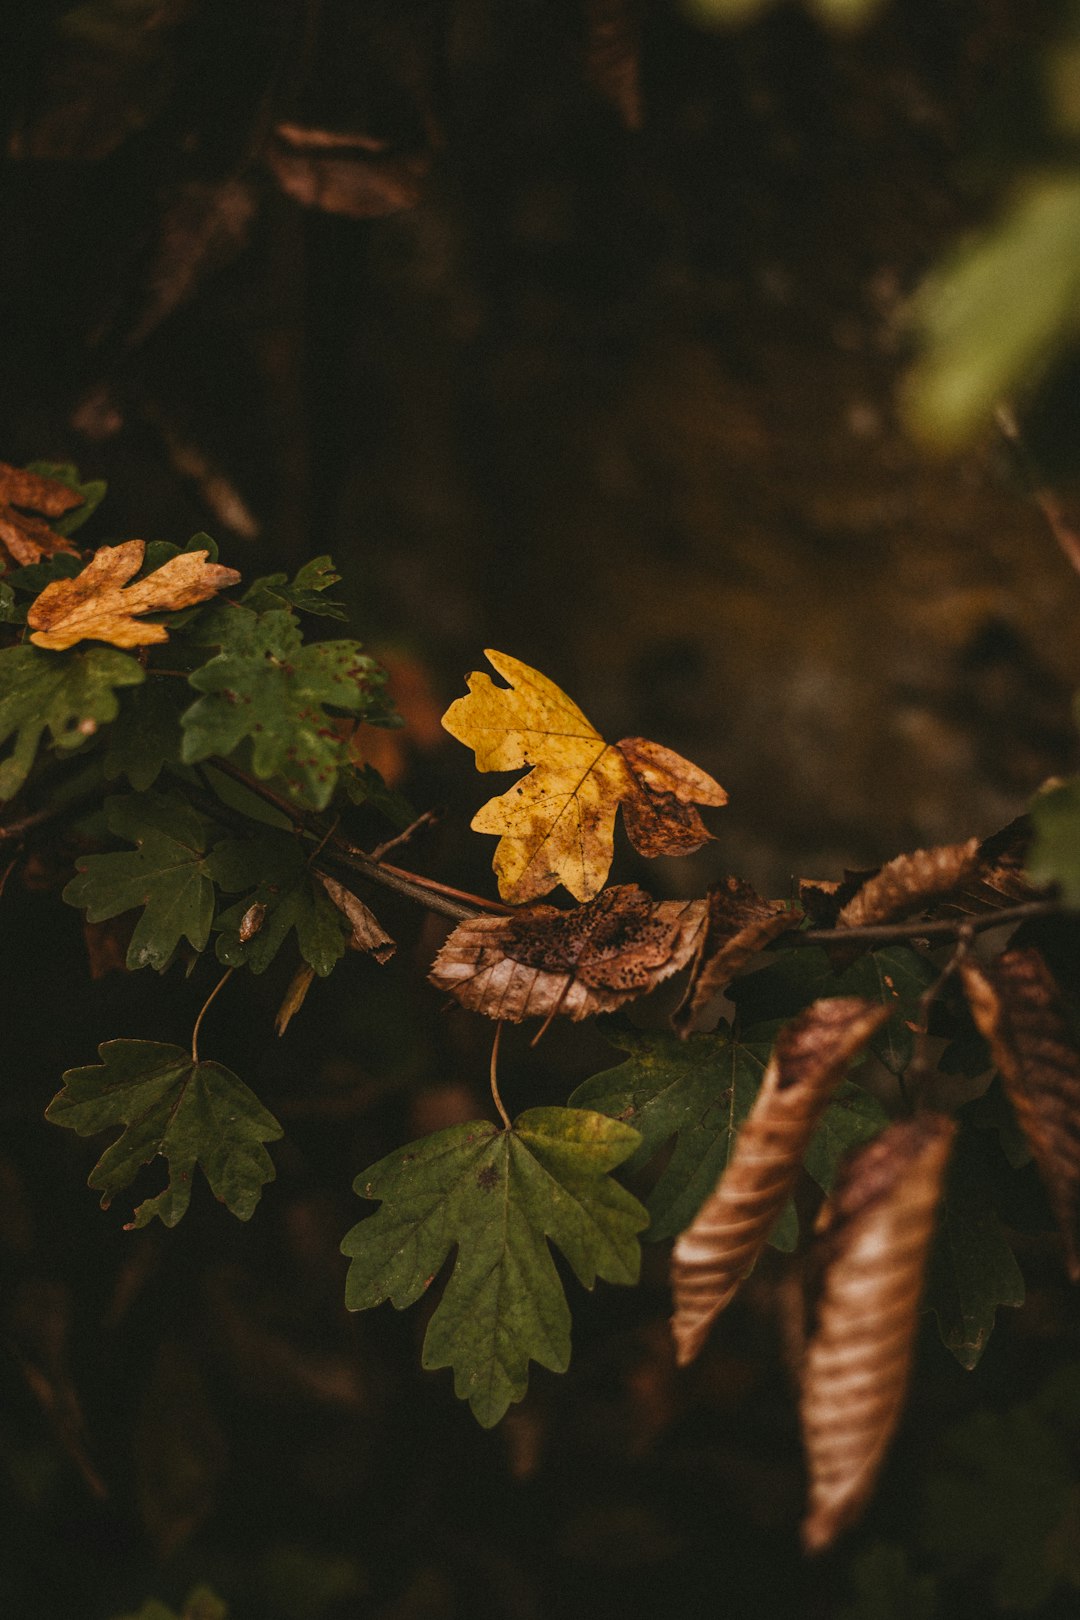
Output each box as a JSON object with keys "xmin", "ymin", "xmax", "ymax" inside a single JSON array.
[{"xmin": 266, "ymin": 123, "xmax": 431, "ymax": 219}]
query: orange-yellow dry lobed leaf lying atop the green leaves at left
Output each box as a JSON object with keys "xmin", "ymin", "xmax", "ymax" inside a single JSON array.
[{"xmin": 26, "ymin": 539, "xmax": 240, "ymax": 651}]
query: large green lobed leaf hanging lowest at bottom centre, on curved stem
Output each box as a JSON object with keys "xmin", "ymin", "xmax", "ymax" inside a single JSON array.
[{"xmin": 342, "ymin": 1108, "xmax": 648, "ymax": 1429}]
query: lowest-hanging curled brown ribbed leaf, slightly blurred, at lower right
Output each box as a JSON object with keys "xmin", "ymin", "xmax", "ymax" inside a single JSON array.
[{"xmin": 800, "ymin": 1113, "xmax": 955, "ymax": 1552}]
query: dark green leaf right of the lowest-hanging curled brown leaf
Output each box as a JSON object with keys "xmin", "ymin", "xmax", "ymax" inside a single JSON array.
[{"xmin": 923, "ymin": 1131, "xmax": 1023, "ymax": 1369}]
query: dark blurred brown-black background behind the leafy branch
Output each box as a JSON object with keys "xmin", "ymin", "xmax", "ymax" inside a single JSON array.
[{"xmin": 0, "ymin": 0, "xmax": 1080, "ymax": 1620}]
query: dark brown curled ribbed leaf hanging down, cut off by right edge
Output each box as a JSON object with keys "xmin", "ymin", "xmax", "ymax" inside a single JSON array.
[{"xmin": 960, "ymin": 946, "xmax": 1080, "ymax": 1283}]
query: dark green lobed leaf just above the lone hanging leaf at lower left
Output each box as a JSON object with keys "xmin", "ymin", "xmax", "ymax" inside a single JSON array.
[{"xmin": 63, "ymin": 794, "xmax": 214, "ymax": 970}]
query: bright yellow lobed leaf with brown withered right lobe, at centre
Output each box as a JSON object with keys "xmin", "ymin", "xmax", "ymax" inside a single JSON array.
[{"xmin": 442, "ymin": 650, "xmax": 727, "ymax": 904}]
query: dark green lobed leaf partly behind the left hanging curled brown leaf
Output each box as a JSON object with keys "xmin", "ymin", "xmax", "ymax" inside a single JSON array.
[{"xmin": 570, "ymin": 1025, "xmax": 798, "ymax": 1252}]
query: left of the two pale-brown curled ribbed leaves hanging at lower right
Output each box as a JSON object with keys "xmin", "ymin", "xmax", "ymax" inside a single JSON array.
[{"xmin": 672, "ymin": 996, "xmax": 889, "ymax": 1366}]
